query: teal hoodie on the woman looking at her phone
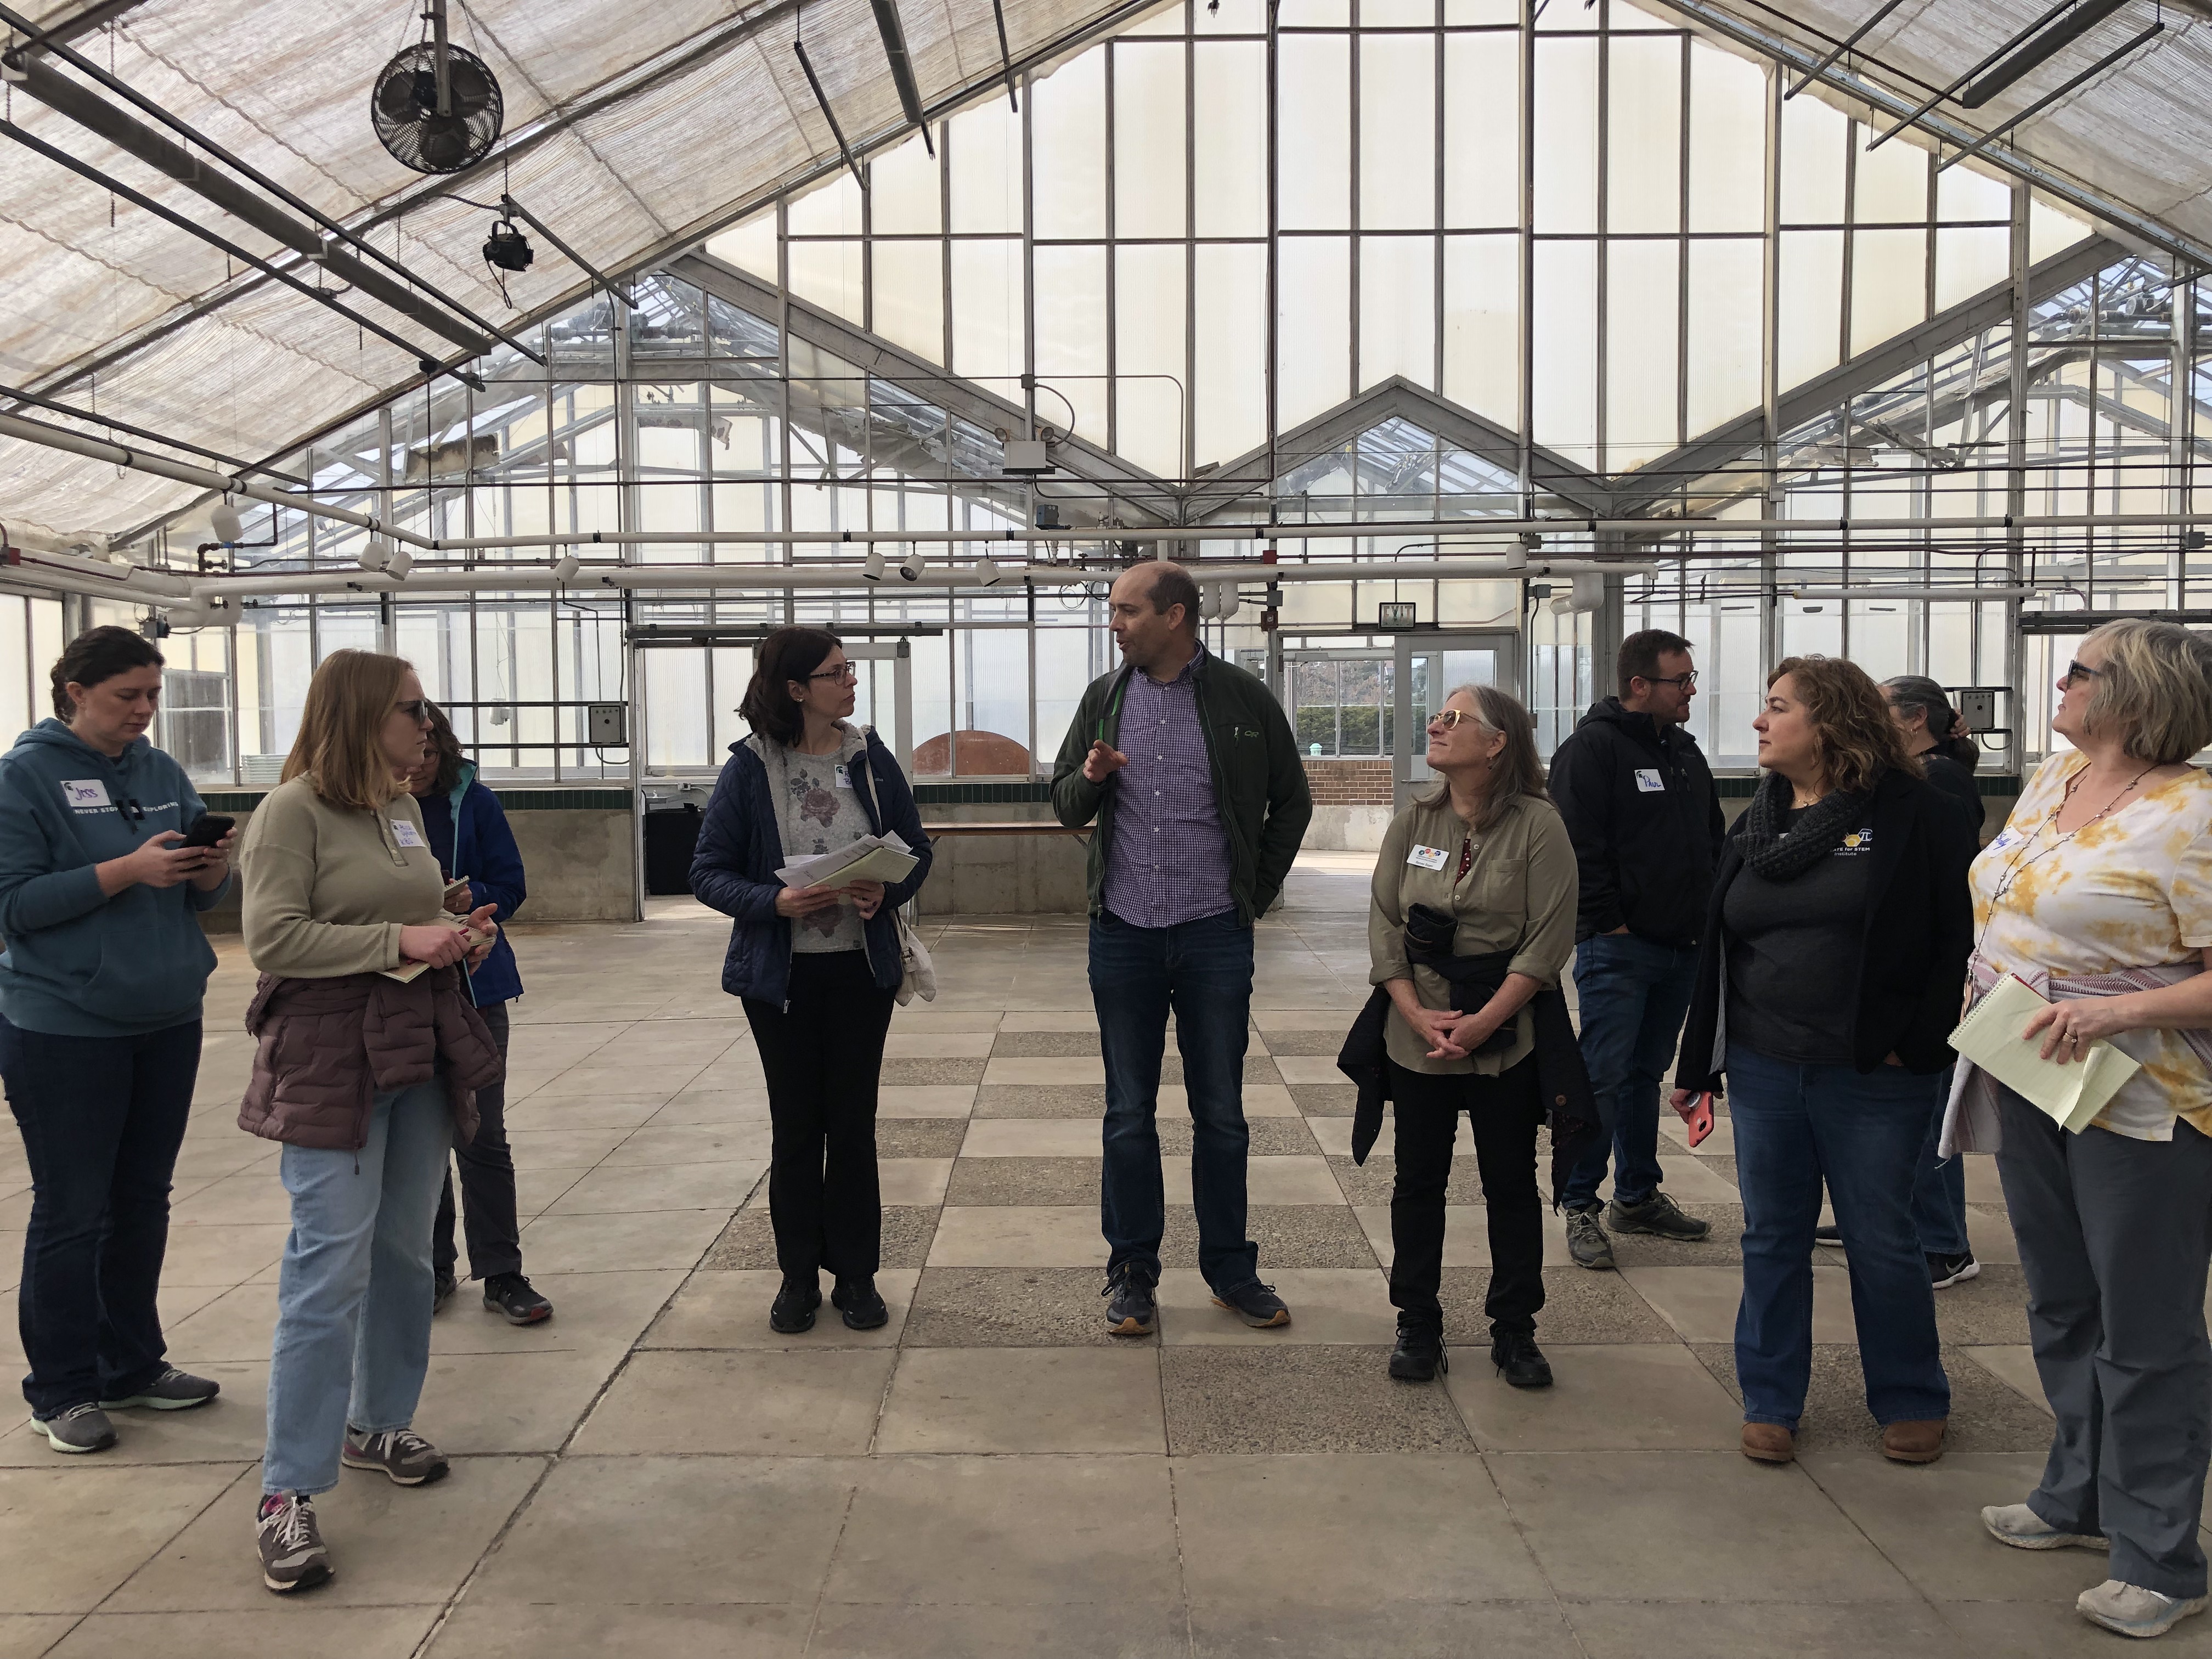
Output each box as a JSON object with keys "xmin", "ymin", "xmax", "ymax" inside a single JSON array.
[{"xmin": 0, "ymin": 719, "xmax": 228, "ymax": 1037}]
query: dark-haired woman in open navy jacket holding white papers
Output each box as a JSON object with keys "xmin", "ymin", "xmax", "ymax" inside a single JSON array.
[{"xmin": 690, "ymin": 628, "xmax": 929, "ymax": 1336}]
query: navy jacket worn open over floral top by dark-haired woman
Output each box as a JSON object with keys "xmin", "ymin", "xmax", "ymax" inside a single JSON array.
[{"xmin": 692, "ymin": 730, "xmax": 929, "ymax": 1009}]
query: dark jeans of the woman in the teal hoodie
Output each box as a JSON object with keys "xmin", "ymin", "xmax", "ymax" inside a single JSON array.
[{"xmin": 0, "ymin": 1020, "xmax": 199, "ymax": 1418}]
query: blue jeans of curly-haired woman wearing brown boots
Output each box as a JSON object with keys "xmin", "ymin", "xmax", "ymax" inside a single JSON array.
[{"xmin": 1728, "ymin": 1042, "xmax": 1951, "ymax": 1429}]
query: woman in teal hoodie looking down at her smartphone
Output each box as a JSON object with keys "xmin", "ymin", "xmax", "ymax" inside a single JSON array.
[{"xmin": 0, "ymin": 628, "xmax": 236, "ymax": 1451}]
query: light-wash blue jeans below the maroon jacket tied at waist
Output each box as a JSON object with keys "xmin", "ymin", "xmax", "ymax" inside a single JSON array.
[{"xmin": 261, "ymin": 1080, "xmax": 454, "ymax": 1493}]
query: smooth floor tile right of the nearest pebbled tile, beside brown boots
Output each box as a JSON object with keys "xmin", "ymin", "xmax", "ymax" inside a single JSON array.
[{"xmin": 1447, "ymin": 1342, "xmax": 1743, "ymax": 1451}]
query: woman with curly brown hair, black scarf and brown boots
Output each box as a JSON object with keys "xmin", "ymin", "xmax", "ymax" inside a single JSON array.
[{"xmin": 1672, "ymin": 657, "xmax": 1973, "ymax": 1462}]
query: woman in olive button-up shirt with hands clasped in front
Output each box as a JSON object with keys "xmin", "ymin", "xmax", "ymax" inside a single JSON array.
[{"xmin": 1367, "ymin": 686, "xmax": 1577, "ymax": 1389}]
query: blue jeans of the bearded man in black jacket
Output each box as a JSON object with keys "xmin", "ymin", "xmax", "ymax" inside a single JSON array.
[{"xmin": 1566, "ymin": 934, "xmax": 1697, "ymax": 1210}]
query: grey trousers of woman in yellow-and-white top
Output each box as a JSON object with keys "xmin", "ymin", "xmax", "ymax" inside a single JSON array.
[{"xmin": 1997, "ymin": 1088, "xmax": 2212, "ymax": 1597}]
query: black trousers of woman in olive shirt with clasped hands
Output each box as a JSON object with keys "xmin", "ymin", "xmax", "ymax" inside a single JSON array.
[{"xmin": 1389, "ymin": 1055, "xmax": 1544, "ymax": 1336}]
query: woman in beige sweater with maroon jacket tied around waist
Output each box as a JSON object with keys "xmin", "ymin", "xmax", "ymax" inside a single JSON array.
[{"xmin": 239, "ymin": 650, "xmax": 504, "ymax": 1593}]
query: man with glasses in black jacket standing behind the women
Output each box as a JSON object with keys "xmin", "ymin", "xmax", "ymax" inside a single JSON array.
[{"xmin": 1550, "ymin": 628, "xmax": 1725, "ymax": 1267}]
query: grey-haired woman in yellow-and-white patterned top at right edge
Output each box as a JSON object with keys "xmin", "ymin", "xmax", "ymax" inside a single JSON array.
[{"xmin": 1944, "ymin": 619, "xmax": 2212, "ymax": 1637}]
